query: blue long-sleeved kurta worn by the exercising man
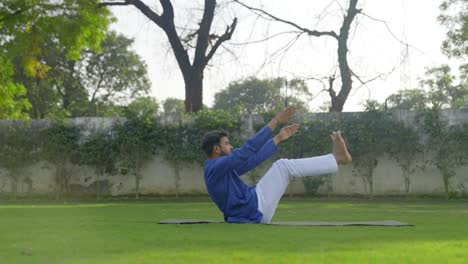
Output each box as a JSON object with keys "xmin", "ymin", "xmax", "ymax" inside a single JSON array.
[{"xmin": 204, "ymin": 126, "xmax": 278, "ymax": 223}]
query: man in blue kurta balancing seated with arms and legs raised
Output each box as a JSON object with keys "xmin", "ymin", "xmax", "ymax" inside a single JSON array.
[{"xmin": 202, "ymin": 107, "xmax": 351, "ymax": 223}]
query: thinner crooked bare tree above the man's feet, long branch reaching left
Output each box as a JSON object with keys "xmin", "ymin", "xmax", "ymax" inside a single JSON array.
[{"xmin": 234, "ymin": 0, "xmax": 365, "ymax": 112}]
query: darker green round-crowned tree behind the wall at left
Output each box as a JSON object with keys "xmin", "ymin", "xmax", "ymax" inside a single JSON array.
[{"xmin": 15, "ymin": 32, "xmax": 150, "ymax": 118}]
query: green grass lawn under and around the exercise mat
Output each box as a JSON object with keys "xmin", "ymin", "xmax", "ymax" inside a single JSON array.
[{"xmin": 0, "ymin": 198, "xmax": 468, "ymax": 264}]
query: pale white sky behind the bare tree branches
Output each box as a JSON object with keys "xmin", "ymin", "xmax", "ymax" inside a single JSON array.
[{"xmin": 111, "ymin": 0, "xmax": 452, "ymax": 111}]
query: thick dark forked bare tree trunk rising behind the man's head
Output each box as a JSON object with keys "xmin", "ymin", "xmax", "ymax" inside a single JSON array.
[{"xmin": 98, "ymin": 0, "xmax": 237, "ymax": 112}]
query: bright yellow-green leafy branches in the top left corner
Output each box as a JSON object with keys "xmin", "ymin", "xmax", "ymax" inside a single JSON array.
[{"xmin": 0, "ymin": 0, "xmax": 111, "ymax": 114}]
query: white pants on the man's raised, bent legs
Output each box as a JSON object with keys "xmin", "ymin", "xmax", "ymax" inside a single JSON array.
[{"xmin": 256, "ymin": 154, "xmax": 338, "ymax": 223}]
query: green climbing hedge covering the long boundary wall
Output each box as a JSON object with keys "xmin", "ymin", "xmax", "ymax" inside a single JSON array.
[{"xmin": 0, "ymin": 109, "xmax": 468, "ymax": 199}]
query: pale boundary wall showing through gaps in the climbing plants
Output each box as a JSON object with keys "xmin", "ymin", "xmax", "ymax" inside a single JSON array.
[{"xmin": 0, "ymin": 110, "xmax": 468, "ymax": 198}]
